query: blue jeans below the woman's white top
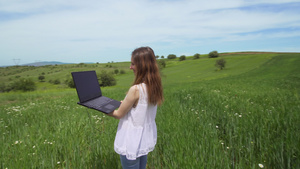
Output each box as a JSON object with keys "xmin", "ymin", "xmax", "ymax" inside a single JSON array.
[{"xmin": 120, "ymin": 155, "xmax": 147, "ymax": 169}]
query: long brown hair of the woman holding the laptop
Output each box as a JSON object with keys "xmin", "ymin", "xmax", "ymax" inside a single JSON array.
[{"xmin": 131, "ymin": 47, "xmax": 163, "ymax": 105}]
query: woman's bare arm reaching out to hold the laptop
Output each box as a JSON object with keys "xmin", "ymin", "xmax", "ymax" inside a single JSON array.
[{"xmin": 107, "ymin": 86, "xmax": 139, "ymax": 119}]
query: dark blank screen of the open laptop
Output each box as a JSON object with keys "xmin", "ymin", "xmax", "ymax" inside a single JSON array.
[{"xmin": 72, "ymin": 71, "xmax": 102, "ymax": 103}]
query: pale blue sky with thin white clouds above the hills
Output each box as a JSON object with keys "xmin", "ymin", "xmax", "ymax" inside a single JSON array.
[{"xmin": 0, "ymin": 0, "xmax": 300, "ymax": 66}]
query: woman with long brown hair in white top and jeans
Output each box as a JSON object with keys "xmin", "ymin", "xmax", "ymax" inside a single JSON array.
[{"xmin": 109, "ymin": 47, "xmax": 163, "ymax": 169}]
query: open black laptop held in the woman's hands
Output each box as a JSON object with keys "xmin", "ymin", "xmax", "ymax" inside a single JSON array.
[{"xmin": 71, "ymin": 71, "xmax": 121, "ymax": 114}]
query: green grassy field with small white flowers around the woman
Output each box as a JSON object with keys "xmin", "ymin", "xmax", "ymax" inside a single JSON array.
[{"xmin": 0, "ymin": 53, "xmax": 300, "ymax": 169}]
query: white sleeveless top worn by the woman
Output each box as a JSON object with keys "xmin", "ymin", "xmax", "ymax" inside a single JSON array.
[{"xmin": 114, "ymin": 83, "xmax": 157, "ymax": 160}]
